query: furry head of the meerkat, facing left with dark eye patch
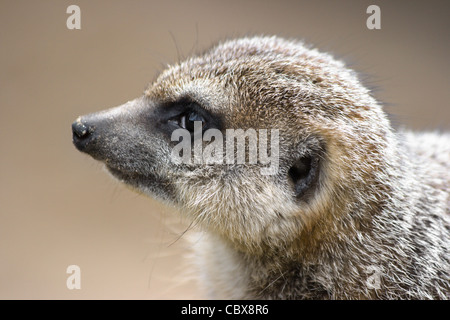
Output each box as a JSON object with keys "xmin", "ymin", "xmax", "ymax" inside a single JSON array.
[{"xmin": 72, "ymin": 37, "xmax": 389, "ymax": 252}]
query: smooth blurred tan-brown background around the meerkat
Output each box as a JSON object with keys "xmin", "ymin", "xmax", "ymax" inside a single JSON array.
[{"xmin": 0, "ymin": 0, "xmax": 450, "ymax": 299}]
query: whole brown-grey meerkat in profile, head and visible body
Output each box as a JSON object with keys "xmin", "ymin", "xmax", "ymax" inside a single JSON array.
[{"xmin": 72, "ymin": 36, "xmax": 450, "ymax": 299}]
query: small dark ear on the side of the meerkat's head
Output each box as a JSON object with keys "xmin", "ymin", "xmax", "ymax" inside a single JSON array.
[{"xmin": 288, "ymin": 155, "xmax": 319, "ymax": 200}]
